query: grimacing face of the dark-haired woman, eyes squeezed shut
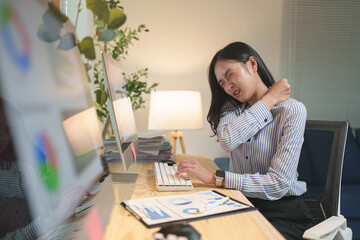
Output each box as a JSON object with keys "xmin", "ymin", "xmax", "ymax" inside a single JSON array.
[{"xmin": 214, "ymin": 57, "xmax": 261, "ymax": 103}]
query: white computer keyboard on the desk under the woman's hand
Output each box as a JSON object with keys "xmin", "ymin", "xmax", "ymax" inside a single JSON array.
[{"xmin": 154, "ymin": 162, "xmax": 193, "ymax": 192}]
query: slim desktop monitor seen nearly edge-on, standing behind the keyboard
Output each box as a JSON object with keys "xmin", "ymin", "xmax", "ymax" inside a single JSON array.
[{"xmin": 101, "ymin": 52, "xmax": 139, "ymax": 170}]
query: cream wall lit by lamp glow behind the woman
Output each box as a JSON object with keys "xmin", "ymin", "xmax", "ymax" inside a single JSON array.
[{"xmin": 121, "ymin": 0, "xmax": 283, "ymax": 158}]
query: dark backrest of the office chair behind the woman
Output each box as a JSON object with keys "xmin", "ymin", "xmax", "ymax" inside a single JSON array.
[{"xmin": 298, "ymin": 120, "xmax": 349, "ymax": 222}]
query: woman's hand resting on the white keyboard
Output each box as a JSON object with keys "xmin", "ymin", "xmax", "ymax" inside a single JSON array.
[{"xmin": 176, "ymin": 159, "xmax": 215, "ymax": 184}]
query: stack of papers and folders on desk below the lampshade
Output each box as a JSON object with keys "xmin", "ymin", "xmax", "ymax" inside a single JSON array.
[{"xmin": 136, "ymin": 132, "xmax": 174, "ymax": 162}]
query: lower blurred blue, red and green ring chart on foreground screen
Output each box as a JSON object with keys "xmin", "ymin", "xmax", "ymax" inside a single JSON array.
[{"xmin": 36, "ymin": 132, "xmax": 59, "ymax": 192}]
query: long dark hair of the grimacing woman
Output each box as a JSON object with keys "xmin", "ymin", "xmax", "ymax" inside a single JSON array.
[{"xmin": 207, "ymin": 42, "xmax": 275, "ymax": 136}]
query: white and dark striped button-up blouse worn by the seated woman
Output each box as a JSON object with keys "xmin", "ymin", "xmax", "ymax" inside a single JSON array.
[{"xmin": 217, "ymin": 98, "xmax": 306, "ymax": 200}]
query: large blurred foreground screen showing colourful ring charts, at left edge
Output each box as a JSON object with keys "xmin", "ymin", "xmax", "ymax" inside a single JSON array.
[{"xmin": 0, "ymin": 0, "xmax": 111, "ymax": 238}]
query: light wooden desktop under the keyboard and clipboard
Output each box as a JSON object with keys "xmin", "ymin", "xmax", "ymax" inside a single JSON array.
[{"xmin": 105, "ymin": 155, "xmax": 285, "ymax": 240}]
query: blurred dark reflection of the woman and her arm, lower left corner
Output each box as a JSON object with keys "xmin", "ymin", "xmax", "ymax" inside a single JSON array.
[{"xmin": 0, "ymin": 100, "xmax": 89, "ymax": 240}]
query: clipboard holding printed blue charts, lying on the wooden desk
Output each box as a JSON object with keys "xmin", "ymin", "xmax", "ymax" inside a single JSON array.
[{"xmin": 121, "ymin": 190, "xmax": 256, "ymax": 228}]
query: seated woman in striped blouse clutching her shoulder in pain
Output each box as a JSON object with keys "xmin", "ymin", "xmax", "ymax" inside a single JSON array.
[{"xmin": 178, "ymin": 42, "xmax": 313, "ymax": 239}]
